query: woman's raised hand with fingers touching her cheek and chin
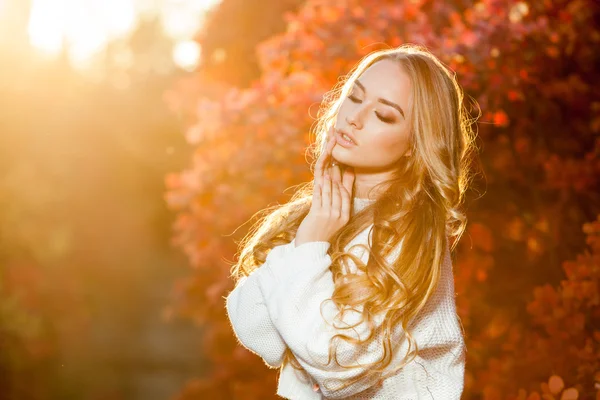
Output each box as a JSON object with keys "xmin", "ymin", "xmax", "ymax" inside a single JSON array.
[{"xmin": 295, "ymin": 127, "xmax": 354, "ymax": 247}]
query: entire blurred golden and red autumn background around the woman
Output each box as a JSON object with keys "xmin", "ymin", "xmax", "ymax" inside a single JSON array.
[{"xmin": 0, "ymin": 0, "xmax": 600, "ymax": 400}]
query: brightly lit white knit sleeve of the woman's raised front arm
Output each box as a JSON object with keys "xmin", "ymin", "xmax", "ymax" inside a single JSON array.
[{"xmin": 257, "ymin": 240, "xmax": 464, "ymax": 398}]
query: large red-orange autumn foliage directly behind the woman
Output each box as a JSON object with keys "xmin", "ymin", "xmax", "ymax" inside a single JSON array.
[{"xmin": 166, "ymin": 0, "xmax": 600, "ymax": 400}]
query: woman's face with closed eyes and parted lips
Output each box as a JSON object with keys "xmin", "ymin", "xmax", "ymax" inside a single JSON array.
[{"xmin": 332, "ymin": 60, "xmax": 411, "ymax": 173}]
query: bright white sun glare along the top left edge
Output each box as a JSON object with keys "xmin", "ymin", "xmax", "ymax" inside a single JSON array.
[{"xmin": 26, "ymin": 0, "xmax": 218, "ymax": 70}]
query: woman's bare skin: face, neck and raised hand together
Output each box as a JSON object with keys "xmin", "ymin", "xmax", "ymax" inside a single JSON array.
[{"xmin": 295, "ymin": 60, "xmax": 412, "ymax": 247}]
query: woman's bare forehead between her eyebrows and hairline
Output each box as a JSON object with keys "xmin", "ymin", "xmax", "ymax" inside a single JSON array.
[{"xmin": 358, "ymin": 60, "xmax": 411, "ymax": 108}]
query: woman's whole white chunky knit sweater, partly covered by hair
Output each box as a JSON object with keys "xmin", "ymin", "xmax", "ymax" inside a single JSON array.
[{"xmin": 226, "ymin": 198, "xmax": 466, "ymax": 400}]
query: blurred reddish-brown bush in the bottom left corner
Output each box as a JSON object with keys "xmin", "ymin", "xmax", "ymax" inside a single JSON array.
[{"xmin": 0, "ymin": 253, "xmax": 87, "ymax": 400}]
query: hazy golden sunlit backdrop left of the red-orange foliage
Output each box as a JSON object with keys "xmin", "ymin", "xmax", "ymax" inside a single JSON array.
[{"xmin": 0, "ymin": 0, "xmax": 220, "ymax": 399}]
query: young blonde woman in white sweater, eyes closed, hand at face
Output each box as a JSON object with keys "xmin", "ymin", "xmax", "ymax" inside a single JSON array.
[{"xmin": 226, "ymin": 45, "xmax": 474, "ymax": 400}]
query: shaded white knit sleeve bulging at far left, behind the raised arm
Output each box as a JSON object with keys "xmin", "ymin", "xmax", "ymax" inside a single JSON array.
[{"xmin": 225, "ymin": 243, "xmax": 293, "ymax": 368}]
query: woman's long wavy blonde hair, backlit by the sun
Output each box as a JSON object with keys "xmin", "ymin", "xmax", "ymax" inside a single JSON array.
[{"xmin": 232, "ymin": 44, "xmax": 477, "ymax": 389}]
